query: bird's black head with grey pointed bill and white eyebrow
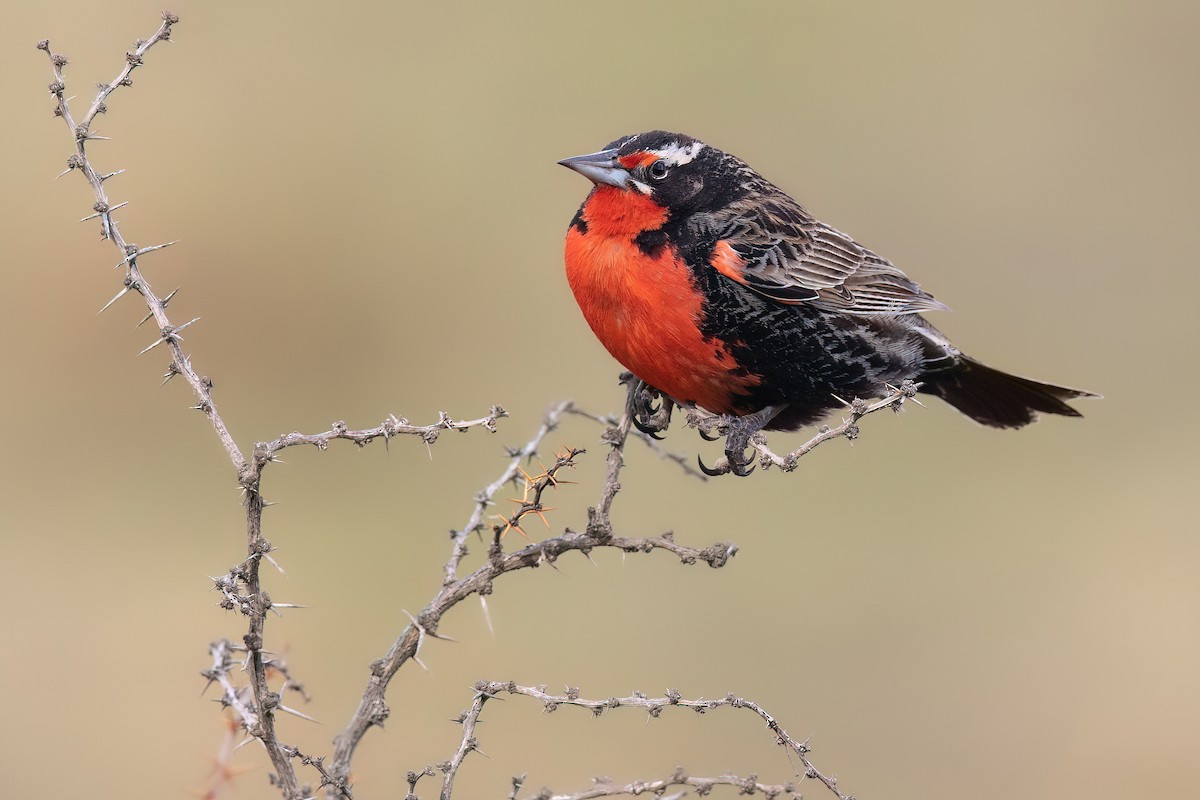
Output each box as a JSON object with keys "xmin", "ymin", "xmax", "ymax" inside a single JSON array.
[{"xmin": 558, "ymin": 131, "xmax": 749, "ymax": 212}]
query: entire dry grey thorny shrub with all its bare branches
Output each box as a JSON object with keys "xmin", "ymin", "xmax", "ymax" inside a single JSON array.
[{"xmin": 37, "ymin": 12, "xmax": 916, "ymax": 800}]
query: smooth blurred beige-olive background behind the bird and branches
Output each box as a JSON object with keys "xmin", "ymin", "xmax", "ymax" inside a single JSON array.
[{"xmin": 0, "ymin": 0, "xmax": 1200, "ymax": 800}]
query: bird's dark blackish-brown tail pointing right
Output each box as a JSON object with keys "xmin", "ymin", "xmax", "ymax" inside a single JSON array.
[{"xmin": 920, "ymin": 356, "xmax": 1099, "ymax": 428}]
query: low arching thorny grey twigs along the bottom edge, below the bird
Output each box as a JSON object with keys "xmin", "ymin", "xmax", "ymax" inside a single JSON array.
[{"xmin": 422, "ymin": 680, "xmax": 853, "ymax": 800}]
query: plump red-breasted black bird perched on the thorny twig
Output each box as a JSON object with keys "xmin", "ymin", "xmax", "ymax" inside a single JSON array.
[{"xmin": 558, "ymin": 131, "xmax": 1097, "ymax": 475}]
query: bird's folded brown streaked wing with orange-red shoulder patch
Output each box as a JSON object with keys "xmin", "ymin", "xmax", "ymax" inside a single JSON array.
[{"xmin": 706, "ymin": 193, "xmax": 947, "ymax": 314}]
